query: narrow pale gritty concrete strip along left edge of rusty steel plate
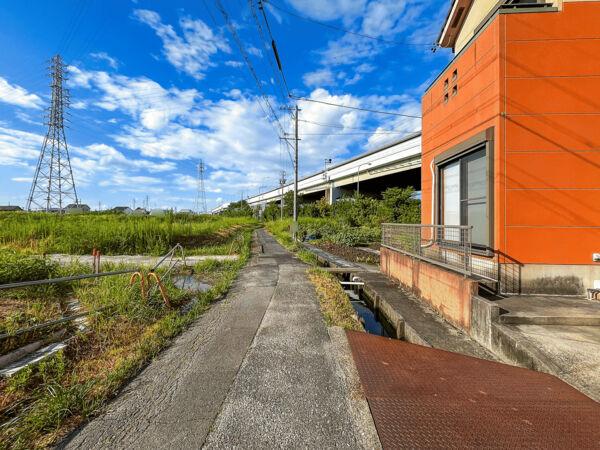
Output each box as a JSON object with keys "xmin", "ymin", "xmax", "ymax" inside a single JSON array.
[{"xmin": 327, "ymin": 327, "xmax": 382, "ymax": 449}]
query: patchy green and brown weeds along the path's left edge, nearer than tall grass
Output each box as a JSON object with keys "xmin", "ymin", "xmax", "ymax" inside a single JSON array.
[{"xmin": 0, "ymin": 221, "xmax": 252, "ymax": 449}]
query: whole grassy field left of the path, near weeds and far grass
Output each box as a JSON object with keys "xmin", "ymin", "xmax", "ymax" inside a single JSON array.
[{"xmin": 0, "ymin": 214, "xmax": 255, "ymax": 449}]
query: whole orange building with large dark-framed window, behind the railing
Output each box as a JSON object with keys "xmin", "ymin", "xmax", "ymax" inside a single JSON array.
[{"xmin": 422, "ymin": 0, "xmax": 600, "ymax": 294}]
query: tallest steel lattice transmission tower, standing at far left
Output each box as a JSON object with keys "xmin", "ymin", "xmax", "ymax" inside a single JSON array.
[{"xmin": 27, "ymin": 55, "xmax": 79, "ymax": 212}]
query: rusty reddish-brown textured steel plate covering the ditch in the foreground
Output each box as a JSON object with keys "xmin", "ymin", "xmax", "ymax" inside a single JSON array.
[{"xmin": 347, "ymin": 331, "xmax": 600, "ymax": 449}]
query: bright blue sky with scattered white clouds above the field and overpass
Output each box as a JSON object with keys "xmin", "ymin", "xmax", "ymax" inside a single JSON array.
[{"xmin": 0, "ymin": 0, "xmax": 450, "ymax": 209}]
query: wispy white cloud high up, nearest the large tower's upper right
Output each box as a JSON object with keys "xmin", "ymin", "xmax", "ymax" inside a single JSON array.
[{"xmin": 134, "ymin": 9, "xmax": 231, "ymax": 80}]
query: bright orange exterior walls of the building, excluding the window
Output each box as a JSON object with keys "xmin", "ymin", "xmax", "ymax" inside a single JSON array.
[{"xmin": 422, "ymin": 1, "xmax": 600, "ymax": 292}]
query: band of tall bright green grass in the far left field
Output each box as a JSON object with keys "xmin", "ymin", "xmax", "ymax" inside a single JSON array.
[{"xmin": 0, "ymin": 213, "xmax": 256, "ymax": 255}]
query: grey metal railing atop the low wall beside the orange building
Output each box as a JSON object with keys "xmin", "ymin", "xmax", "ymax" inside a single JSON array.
[{"xmin": 381, "ymin": 223, "xmax": 498, "ymax": 281}]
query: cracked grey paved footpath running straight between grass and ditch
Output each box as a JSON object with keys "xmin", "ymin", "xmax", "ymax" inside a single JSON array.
[{"xmin": 59, "ymin": 230, "xmax": 379, "ymax": 449}]
